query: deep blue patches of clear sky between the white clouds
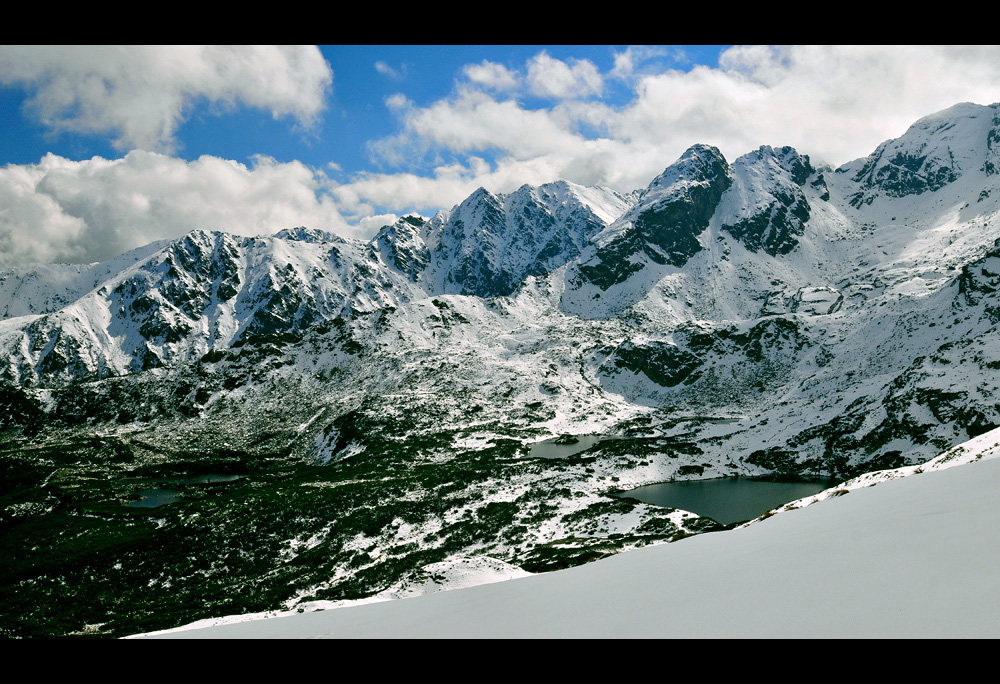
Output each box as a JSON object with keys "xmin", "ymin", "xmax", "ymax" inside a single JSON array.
[{"xmin": 0, "ymin": 45, "xmax": 725, "ymax": 174}]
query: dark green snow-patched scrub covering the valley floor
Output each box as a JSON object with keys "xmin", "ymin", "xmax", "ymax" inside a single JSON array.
[{"xmin": 0, "ymin": 405, "xmax": 711, "ymax": 637}]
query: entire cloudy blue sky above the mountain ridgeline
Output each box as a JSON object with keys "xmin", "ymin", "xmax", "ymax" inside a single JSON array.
[{"xmin": 0, "ymin": 45, "xmax": 1000, "ymax": 268}]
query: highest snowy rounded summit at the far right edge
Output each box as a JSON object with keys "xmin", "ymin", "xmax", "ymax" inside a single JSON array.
[{"xmin": 837, "ymin": 103, "xmax": 1000, "ymax": 208}]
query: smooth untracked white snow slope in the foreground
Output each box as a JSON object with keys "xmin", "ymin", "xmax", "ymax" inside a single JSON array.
[{"xmin": 137, "ymin": 430, "xmax": 1000, "ymax": 638}]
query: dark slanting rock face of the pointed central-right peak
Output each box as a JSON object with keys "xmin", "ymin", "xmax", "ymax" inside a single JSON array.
[{"xmin": 579, "ymin": 145, "xmax": 732, "ymax": 290}]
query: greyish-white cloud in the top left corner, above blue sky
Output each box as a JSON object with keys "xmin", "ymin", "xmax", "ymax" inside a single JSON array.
[{"xmin": 0, "ymin": 45, "xmax": 333, "ymax": 151}]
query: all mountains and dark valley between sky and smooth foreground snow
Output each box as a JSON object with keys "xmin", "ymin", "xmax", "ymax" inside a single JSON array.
[{"xmin": 0, "ymin": 104, "xmax": 1000, "ymax": 635}]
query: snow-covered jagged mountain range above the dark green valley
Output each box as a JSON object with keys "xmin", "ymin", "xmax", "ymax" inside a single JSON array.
[{"xmin": 7, "ymin": 104, "xmax": 1000, "ymax": 474}]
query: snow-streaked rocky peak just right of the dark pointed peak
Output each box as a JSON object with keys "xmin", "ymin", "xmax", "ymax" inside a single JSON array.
[{"xmin": 720, "ymin": 146, "xmax": 814, "ymax": 256}]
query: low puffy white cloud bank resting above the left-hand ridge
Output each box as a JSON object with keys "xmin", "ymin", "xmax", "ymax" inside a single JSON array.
[{"xmin": 0, "ymin": 150, "xmax": 360, "ymax": 266}]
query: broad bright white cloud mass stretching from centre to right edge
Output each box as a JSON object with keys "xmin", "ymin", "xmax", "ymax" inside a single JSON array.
[{"xmin": 350, "ymin": 45, "xmax": 1000, "ymax": 216}]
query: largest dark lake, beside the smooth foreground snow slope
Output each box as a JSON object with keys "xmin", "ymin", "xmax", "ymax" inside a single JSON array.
[{"xmin": 614, "ymin": 477, "xmax": 837, "ymax": 525}]
